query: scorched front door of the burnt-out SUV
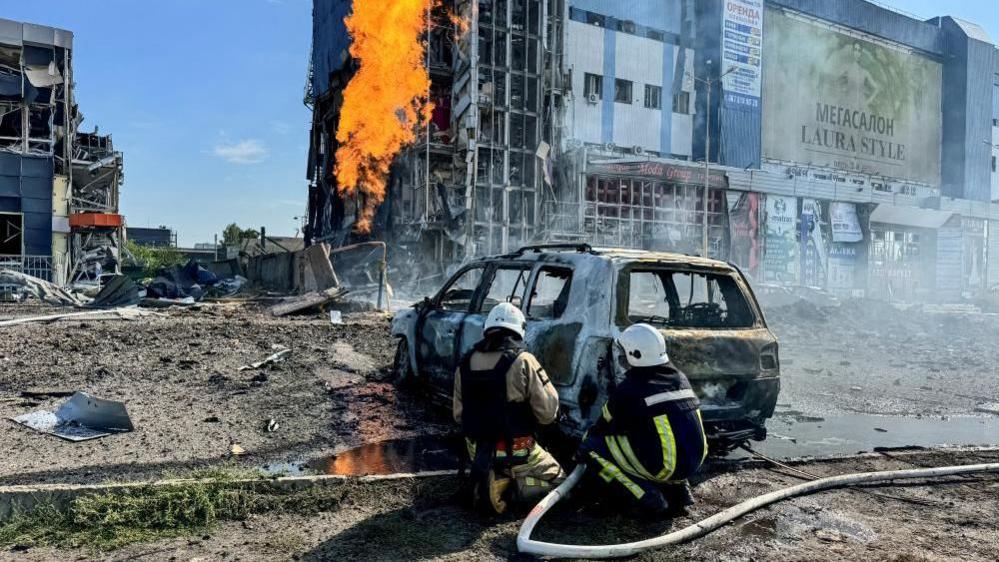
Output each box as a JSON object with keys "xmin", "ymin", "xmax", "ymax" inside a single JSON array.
[{"xmin": 416, "ymin": 264, "xmax": 487, "ymax": 393}]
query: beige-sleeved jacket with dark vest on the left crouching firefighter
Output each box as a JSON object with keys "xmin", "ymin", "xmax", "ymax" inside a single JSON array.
[{"xmin": 453, "ymin": 339, "xmax": 558, "ymax": 457}]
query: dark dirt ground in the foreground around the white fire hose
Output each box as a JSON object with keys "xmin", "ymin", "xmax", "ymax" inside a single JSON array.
[{"xmin": 7, "ymin": 449, "xmax": 999, "ymax": 562}]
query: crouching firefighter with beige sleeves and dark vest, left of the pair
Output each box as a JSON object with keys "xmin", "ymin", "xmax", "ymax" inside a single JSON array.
[{"xmin": 454, "ymin": 303, "xmax": 564, "ymax": 514}]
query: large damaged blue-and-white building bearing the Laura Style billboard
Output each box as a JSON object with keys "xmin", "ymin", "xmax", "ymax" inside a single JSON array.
[{"xmin": 306, "ymin": 0, "xmax": 999, "ymax": 301}]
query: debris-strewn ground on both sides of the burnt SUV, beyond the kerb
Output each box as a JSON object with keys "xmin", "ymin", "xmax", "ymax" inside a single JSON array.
[{"xmin": 0, "ymin": 301, "xmax": 999, "ymax": 484}]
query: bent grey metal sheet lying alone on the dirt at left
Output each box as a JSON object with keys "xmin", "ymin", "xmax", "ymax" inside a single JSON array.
[{"xmin": 11, "ymin": 392, "xmax": 135, "ymax": 441}]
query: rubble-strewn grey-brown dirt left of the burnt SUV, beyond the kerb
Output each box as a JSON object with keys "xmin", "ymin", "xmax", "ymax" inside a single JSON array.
[{"xmin": 0, "ymin": 305, "xmax": 448, "ymax": 485}]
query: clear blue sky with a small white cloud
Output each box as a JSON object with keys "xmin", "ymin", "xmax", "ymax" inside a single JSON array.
[{"xmin": 0, "ymin": 0, "xmax": 999, "ymax": 245}]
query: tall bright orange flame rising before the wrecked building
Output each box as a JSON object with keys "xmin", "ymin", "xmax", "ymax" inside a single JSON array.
[{"xmin": 334, "ymin": 0, "xmax": 433, "ymax": 233}]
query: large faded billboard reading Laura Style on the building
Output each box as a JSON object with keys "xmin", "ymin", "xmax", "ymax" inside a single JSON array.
[{"xmin": 763, "ymin": 10, "xmax": 942, "ymax": 185}]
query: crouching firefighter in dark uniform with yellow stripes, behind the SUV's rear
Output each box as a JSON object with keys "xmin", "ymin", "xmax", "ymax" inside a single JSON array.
[{"xmin": 580, "ymin": 324, "xmax": 708, "ymax": 518}]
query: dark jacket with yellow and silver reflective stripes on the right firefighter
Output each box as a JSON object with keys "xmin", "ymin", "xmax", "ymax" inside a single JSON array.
[{"xmin": 583, "ymin": 364, "xmax": 708, "ymax": 482}]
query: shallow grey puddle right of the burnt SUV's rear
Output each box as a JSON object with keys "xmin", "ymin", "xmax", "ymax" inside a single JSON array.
[{"xmin": 753, "ymin": 414, "xmax": 999, "ymax": 457}]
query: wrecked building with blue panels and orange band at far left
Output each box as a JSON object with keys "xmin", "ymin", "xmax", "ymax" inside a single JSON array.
[{"xmin": 0, "ymin": 19, "xmax": 123, "ymax": 284}]
